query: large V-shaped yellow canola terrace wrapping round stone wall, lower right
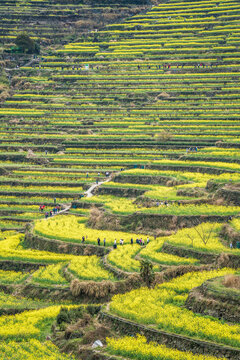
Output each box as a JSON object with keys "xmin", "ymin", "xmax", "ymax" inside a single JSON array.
[{"xmin": 110, "ymin": 269, "xmax": 240, "ymax": 348}]
